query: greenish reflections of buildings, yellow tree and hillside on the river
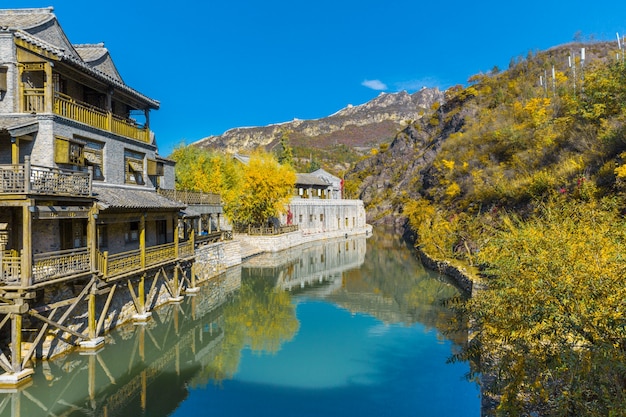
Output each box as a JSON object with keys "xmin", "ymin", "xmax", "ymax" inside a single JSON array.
[{"xmin": 0, "ymin": 235, "xmax": 464, "ymax": 417}]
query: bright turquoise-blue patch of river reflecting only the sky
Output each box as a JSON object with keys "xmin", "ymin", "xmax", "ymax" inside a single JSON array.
[{"xmin": 173, "ymin": 299, "xmax": 480, "ymax": 417}]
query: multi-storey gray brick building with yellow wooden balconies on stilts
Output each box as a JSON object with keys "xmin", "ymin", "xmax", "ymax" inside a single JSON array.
[{"xmin": 0, "ymin": 8, "xmax": 200, "ymax": 385}]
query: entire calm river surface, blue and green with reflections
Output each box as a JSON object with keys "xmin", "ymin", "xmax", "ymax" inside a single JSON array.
[{"xmin": 0, "ymin": 231, "xmax": 480, "ymax": 417}]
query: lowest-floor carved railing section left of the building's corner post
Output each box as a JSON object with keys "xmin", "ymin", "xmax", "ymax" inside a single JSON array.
[{"xmin": 32, "ymin": 248, "xmax": 91, "ymax": 284}]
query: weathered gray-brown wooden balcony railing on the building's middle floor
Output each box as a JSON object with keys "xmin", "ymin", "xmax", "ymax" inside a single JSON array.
[{"xmin": 0, "ymin": 157, "xmax": 92, "ymax": 197}]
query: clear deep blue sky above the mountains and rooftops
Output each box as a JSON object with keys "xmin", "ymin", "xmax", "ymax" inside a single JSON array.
[{"xmin": 0, "ymin": 0, "xmax": 626, "ymax": 156}]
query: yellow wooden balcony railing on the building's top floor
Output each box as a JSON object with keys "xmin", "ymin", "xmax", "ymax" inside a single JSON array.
[{"xmin": 22, "ymin": 88, "xmax": 150, "ymax": 143}]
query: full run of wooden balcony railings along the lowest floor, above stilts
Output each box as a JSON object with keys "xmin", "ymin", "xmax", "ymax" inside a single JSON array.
[{"xmin": 0, "ymin": 241, "xmax": 194, "ymax": 286}]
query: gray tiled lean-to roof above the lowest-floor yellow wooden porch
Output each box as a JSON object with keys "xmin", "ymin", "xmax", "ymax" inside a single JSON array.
[{"xmin": 93, "ymin": 185, "xmax": 185, "ymax": 210}]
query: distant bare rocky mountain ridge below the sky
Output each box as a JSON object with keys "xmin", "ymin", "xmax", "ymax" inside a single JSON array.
[{"xmin": 192, "ymin": 88, "xmax": 443, "ymax": 152}]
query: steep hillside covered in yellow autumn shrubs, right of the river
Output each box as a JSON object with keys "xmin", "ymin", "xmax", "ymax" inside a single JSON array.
[{"xmin": 346, "ymin": 42, "xmax": 626, "ymax": 416}]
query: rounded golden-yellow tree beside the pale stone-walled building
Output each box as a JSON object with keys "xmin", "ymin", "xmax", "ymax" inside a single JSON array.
[{"xmin": 222, "ymin": 151, "xmax": 296, "ymax": 227}]
